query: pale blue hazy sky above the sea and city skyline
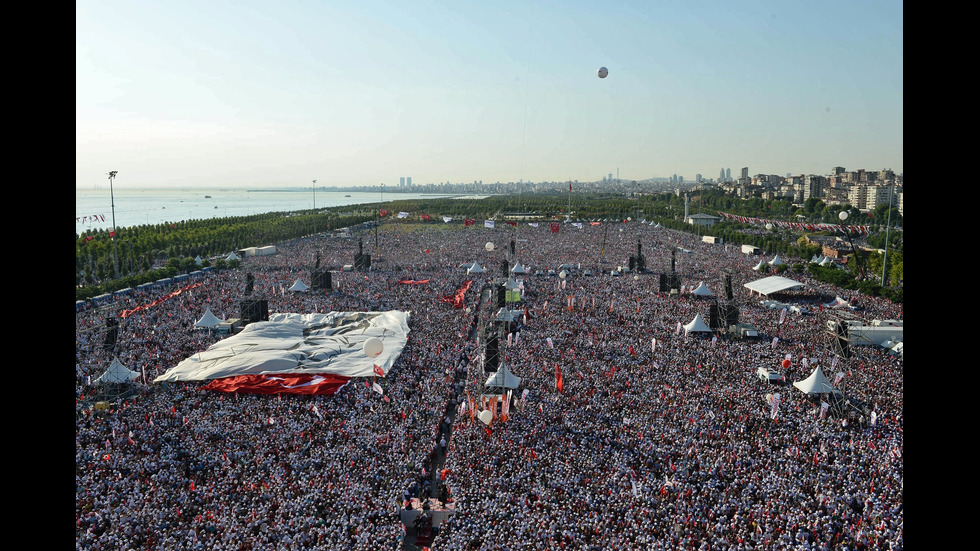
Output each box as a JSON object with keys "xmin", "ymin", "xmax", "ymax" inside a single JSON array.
[{"xmin": 75, "ymin": 0, "xmax": 904, "ymax": 187}]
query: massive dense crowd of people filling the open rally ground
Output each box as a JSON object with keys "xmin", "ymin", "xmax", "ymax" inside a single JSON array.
[{"xmin": 75, "ymin": 223, "xmax": 904, "ymax": 550}]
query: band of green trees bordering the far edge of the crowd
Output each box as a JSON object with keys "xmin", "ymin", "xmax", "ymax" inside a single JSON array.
[{"xmin": 75, "ymin": 191, "xmax": 903, "ymax": 302}]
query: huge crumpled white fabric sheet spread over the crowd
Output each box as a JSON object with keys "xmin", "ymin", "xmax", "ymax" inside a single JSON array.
[{"xmin": 154, "ymin": 310, "xmax": 410, "ymax": 383}]
